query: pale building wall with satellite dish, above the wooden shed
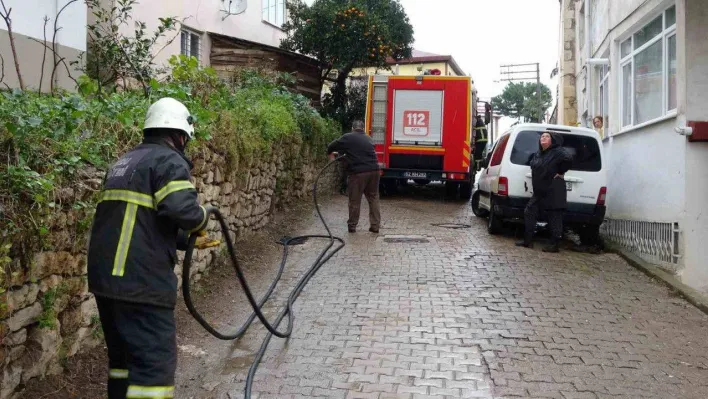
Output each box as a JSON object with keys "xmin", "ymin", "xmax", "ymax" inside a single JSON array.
[{"xmin": 123, "ymin": 0, "xmax": 285, "ymax": 69}]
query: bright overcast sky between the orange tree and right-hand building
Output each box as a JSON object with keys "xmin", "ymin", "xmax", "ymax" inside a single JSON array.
[{"xmin": 400, "ymin": 0, "xmax": 560, "ymax": 133}]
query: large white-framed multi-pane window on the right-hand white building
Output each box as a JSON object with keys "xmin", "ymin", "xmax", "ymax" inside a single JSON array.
[{"xmin": 620, "ymin": 6, "xmax": 676, "ymax": 128}]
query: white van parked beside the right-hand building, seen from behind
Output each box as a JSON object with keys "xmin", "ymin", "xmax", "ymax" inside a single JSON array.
[{"xmin": 472, "ymin": 123, "xmax": 607, "ymax": 244}]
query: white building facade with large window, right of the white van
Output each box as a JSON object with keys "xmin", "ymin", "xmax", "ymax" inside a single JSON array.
[{"xmin": 559, "ymin": 0, "xmax": 708, "ymax": 292}]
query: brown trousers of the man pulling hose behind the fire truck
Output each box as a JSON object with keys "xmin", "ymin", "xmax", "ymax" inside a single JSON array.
[{"xmin": 347, "ymin": 170, "xmax": 381, "ymax": 231}]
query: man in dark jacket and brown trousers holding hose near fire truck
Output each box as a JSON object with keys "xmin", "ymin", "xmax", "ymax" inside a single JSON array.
[{"xmin": 327, "ymin": 121, "xmax": 381, "ymax": 233}]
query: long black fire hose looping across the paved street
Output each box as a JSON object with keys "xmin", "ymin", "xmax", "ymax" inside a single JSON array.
[{"xmin": 182, "ymin": 156, "xmax": 344, "ymax": 399}]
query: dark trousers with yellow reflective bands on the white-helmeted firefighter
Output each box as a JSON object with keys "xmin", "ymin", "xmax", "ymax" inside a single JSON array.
[{"xmin": 96, "ymin": 296, "xmax": 177, "ymax": 399}]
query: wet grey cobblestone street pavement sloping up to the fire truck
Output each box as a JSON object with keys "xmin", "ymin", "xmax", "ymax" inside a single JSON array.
[{"xmin": 180, "ymin": 190, "xmax": 708, "ymax": 399}]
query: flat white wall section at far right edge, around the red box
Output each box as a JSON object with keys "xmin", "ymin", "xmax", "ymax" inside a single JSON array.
[{"xmin": 677, "ymin": 0, "xmax": 708, "ymax": 292}]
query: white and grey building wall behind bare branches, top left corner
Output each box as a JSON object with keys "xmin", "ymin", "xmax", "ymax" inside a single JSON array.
[{"xmin": 0, "ymin": 0, "xmax": 86, "ymax": 91}]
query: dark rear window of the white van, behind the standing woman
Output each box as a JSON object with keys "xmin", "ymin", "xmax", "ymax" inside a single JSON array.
[{"xmin": 511, "ymin": 130, "xmax": 602, "ymax": 172}]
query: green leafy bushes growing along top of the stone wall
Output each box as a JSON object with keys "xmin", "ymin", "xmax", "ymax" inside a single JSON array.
[{"xmin": 0, "ymin": 56, "xmax": 340, "ymax": 294}]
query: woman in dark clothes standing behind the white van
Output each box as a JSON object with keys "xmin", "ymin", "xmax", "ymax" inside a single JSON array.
[{"xmin": 516, "ymin": 132, "xmax": 573, "ymax": 252}]
